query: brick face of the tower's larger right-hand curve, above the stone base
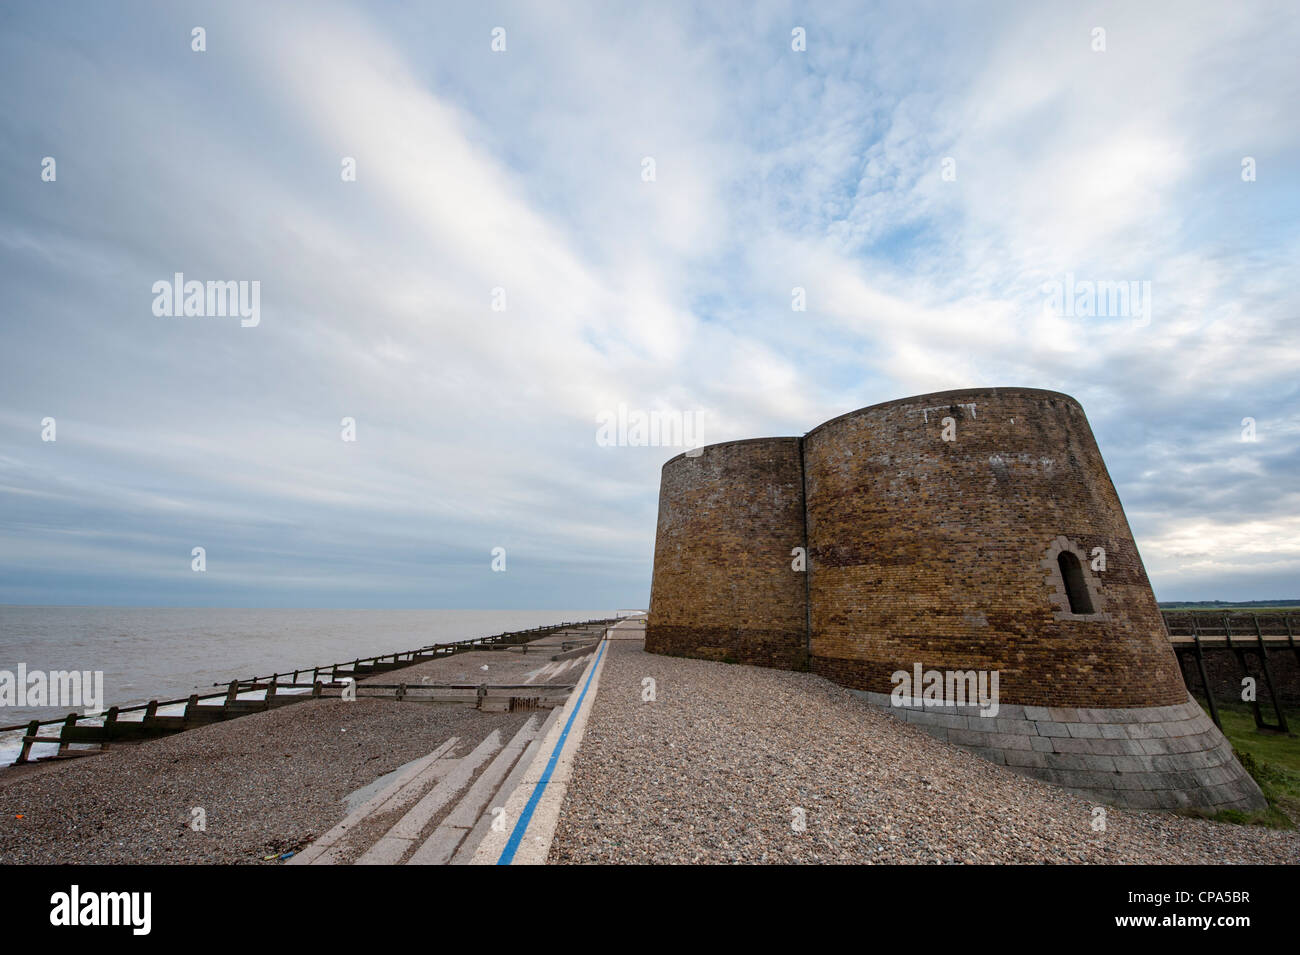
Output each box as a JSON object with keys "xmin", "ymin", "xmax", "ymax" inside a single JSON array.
[{"xmin": 803, "ymin": 388, "xmax": 1186, "ymax": 707}]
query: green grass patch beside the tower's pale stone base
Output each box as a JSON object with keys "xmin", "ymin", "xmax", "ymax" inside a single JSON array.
[{"xmin": 1192, "ymin": 700, "xmax": 1300, "ymax": 829}]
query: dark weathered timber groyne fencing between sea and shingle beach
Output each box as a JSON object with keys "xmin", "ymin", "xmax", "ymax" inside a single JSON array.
[{"xmin": 0, "ymin": 617, "xmax": 618, "ymax": 765}]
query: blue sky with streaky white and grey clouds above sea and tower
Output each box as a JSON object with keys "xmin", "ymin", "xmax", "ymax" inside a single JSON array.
[{"xmin": 0, "ymin": 0, "xmax": 1300, "ymax": 608}]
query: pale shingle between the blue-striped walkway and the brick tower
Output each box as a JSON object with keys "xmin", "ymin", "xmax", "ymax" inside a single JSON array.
[{"xmin": 549, "ymin": 641, "xmax": 1300, "ymax": 864}]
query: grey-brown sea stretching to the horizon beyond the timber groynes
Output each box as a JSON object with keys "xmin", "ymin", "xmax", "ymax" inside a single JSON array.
[{"xmin": 0, "ymin": 605, "xmax": 614, "ymax": 726}]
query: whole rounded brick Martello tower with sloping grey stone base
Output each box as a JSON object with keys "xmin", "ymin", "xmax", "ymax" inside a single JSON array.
[{"xmin": 646, "ymin": 388, "xmax": 1264, "ymax": 808}]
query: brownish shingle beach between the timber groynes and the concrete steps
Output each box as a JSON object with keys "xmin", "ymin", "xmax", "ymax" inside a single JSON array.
[{"xmin": 0, "ymin": 652, "xmax": 549, "ymax": 864}]
